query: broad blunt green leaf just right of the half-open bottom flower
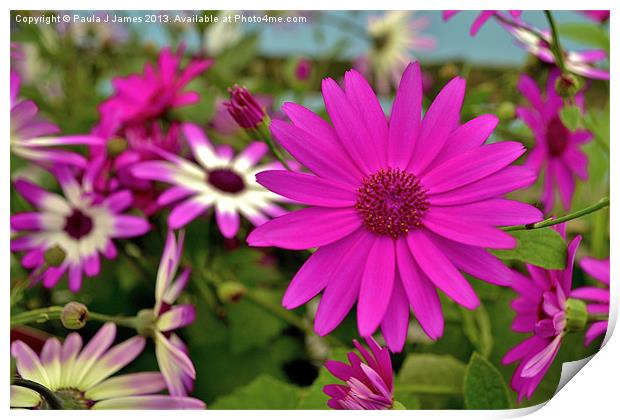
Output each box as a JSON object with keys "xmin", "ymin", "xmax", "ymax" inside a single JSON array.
[{"xmin": 395, "ymin": 354, "xmax": 465, "ymax": 395}]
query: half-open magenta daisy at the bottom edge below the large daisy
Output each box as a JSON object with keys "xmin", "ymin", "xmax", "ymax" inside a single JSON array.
[{"xmin": 323, "ymin": 337, "xmax": 394, "ymax": 410}]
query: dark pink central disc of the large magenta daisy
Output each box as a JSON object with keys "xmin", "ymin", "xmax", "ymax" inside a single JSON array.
[{"xmin": 355, "ymin": 168, "xmax": 429, "ymax": 239}]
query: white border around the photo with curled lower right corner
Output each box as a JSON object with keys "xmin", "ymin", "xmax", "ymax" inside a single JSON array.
[{"xmin": 0, "ymin": 0, "xmax": 620, "ymax": 420}]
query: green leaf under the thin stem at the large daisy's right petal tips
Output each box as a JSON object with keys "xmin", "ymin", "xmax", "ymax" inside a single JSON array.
[{"xmin": 492, "ymin": 228, "xmax": 567, "ymax": 270}]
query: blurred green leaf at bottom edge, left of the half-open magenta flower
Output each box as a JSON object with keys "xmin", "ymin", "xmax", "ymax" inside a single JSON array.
[{"xmin": 209, "ymin": 375, "xmax": 299, "ymax": 410}]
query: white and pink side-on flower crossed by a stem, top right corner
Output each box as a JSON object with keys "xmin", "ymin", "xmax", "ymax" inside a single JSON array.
[{"xmin": 502, "ymin": 21, "xmax": 609, "ymax": 80}]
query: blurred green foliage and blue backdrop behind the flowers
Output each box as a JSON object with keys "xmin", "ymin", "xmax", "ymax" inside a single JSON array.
[{"xmin": 10, "ymin": 11, "xmax": 609, "ymax": 409}]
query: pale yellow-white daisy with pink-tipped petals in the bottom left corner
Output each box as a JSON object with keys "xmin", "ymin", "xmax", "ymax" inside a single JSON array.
[{"xmin": 11, "ymin": 322, "xmax": 205, "ymax": 410}]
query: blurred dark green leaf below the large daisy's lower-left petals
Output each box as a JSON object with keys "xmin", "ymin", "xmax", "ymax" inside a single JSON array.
[{"xmin": 228, "ymin": 289, "xmax": 286, "ymax": 353}]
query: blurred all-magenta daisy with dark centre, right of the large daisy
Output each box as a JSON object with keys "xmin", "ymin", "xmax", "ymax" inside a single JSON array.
[{"xmin": 517, "ymin": 69, "xmax": 592, "ymax": 213}]
